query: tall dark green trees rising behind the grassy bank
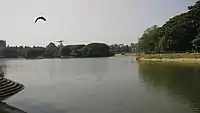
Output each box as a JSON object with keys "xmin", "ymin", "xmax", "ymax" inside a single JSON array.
[{"xmin": 137, "ymin": 0, "xmax": 200, "ymax": 52}]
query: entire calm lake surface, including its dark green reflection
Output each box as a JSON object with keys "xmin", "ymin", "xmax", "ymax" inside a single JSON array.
[{"xmin": 0, "ymin": 57, "xmax": 200, "ymax": 113}]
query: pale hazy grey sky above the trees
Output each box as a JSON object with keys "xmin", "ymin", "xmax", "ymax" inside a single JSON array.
[{"xmin": 0, "ymin": 0, "xmax": 195, "ymax": 46}]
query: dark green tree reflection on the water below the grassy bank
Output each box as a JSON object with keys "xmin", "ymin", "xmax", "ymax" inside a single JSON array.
[{"xmin": 139, "ymin": 62, "xmax": 200, "ymax": 112}]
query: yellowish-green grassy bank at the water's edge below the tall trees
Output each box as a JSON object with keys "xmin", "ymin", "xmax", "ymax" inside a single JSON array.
[{"xmin": 135, "ymin": 53, "xmax": 200, "ymax": 63}]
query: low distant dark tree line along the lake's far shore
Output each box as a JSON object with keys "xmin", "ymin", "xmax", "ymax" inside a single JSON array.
[{"xmin": 0, "ymin": 42, "xmax": 135, "ymax": 59}]
